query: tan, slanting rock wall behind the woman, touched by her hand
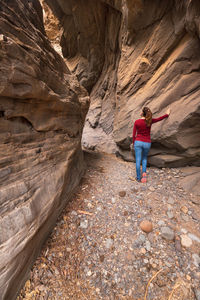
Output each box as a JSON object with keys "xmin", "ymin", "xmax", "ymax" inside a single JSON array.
[{"xmin": 46, "ymin": 0, "xmax": 200, "ymax": 167}]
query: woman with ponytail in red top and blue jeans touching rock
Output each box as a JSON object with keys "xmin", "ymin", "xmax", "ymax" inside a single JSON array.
[{"xmin": 133, "ymin": 107, "xmax": 170, "ymax": 183}]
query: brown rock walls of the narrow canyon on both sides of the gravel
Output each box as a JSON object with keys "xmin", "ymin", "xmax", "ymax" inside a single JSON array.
[{"xmin": 0, "ymin": 0, "xmax": 200, "ymax": 300}]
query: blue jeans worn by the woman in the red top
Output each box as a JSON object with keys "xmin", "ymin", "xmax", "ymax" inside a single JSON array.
[{"xmin": 134, "ymin": 141, "xmax": 151, "ymax": 180}]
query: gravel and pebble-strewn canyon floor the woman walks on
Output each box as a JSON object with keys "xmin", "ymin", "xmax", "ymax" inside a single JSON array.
[{"xmin": 18, "ymin": 153, "xmax": 200, "ymax": 300}]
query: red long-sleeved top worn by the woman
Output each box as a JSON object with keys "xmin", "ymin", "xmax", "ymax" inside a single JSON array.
[{"xmin": 133, "ymin": 114, "xmax": 169, "ymax": 144}]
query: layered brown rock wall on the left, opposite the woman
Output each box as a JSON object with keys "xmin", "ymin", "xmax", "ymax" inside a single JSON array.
[{"xmin": 0, "ymin": 0, "xmax": 88, "ymax": 300}]
